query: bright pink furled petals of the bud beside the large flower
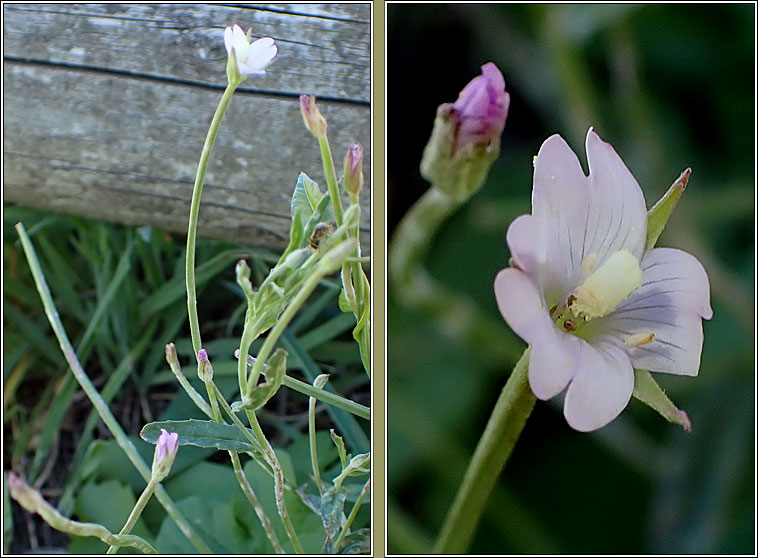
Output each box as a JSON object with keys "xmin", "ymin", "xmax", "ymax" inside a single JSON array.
[{"xmin": 453, "ymin": 62, "xmax": 511, "ymax": 152}]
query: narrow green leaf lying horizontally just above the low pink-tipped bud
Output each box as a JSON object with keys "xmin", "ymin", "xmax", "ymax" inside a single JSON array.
[{"xmin": 140, "ymin": 419, "xmax": 260, "ymax": 452}]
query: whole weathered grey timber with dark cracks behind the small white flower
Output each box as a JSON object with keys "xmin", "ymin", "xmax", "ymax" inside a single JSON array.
[{"xmin": 3, "ymin": 4, "xmax": 371, "ymax": 253}]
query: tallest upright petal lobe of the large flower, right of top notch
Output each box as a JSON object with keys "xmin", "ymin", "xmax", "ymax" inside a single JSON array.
[{"xmin": 585, "ymin": 128, "xmax": 647, "ymax": 263}]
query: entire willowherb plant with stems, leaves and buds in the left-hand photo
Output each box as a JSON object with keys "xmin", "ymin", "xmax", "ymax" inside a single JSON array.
[{"xmin": 9, "ymin": 20, "xmax": 371, "ymax": 554}]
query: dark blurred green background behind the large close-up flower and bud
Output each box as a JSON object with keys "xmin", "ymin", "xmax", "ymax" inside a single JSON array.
[{"xmin": 387, "ymin": 4, "xmax": 755, "ymax": 554}]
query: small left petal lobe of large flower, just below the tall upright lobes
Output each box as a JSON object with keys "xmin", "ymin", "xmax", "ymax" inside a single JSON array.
[{"xmin": 506, "ymin": 215, "xmax": 573, "ymax": 304}]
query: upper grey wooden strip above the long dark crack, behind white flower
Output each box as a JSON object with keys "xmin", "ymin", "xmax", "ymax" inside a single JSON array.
[{"xmin": 3, "ymin": 4, "xmax": 371, "ymax": 100}]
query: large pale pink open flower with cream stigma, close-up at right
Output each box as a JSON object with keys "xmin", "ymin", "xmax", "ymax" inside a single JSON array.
[{"xmin": 495, "ymin": 129, "xmax": 713, "ymax": 431}]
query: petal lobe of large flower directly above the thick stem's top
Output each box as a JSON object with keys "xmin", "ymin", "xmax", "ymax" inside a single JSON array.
[{"xmin": 529, "ymin": 324, "xmax": 584, "ymax": 401}]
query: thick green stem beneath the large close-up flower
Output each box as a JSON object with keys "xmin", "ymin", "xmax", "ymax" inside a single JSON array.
[{"xmin": 432, "ymin": 349, "xmax": 535, "ymax": 554}]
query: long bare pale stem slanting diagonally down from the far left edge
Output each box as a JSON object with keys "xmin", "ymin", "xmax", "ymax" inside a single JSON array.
[{"xmin": 16, "ymin": 223, "xmax": 211, "ymax": 554}]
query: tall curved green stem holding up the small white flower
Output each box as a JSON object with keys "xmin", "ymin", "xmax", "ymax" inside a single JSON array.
[{"xmin": 185, "ymin": 83, "xmax": 236, "ymax": 355}]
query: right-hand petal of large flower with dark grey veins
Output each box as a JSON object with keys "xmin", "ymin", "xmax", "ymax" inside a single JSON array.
[{"xmin": 593, "ymin": 248, "xmax": 713, "ymax": 376}]
